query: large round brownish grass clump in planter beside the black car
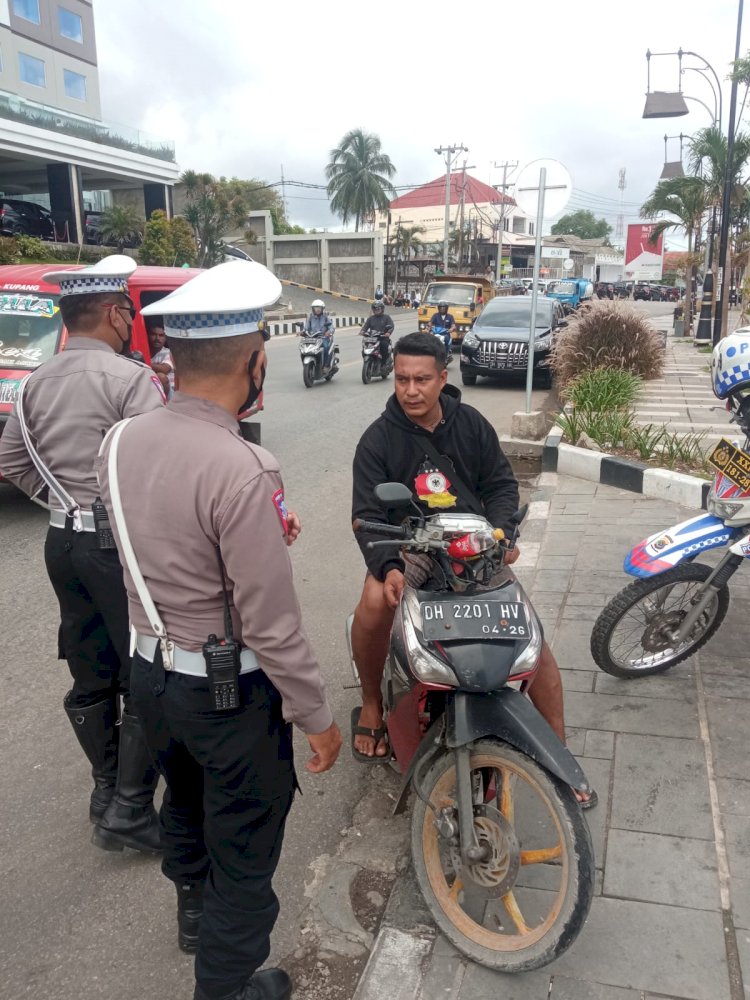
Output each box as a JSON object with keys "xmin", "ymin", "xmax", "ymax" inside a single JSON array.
[{"xmin": 552, "ymin": 302, "xmax": 664, "ymax": 387}]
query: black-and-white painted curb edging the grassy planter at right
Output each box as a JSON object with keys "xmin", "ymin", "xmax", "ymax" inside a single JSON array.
[{"xmin": 542, "ymin": 427, "xmax": 711, "ymax": 510}]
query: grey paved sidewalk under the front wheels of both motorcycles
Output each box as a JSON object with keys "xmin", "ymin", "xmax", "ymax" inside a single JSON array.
[{"xmin": 355, "ymin": 473, "xmax": 750, "ymax": 1000}]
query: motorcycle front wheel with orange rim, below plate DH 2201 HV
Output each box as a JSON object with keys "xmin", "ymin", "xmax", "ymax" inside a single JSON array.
[{"xmin": 411, "ymin": 739, "xmax": 594, "ymax": 972}]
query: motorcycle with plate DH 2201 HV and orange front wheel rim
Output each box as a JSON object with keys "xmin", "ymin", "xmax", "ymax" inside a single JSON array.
[{"xmin": 348, "ymin": 483, "xmax": 594, "ymax": 972}]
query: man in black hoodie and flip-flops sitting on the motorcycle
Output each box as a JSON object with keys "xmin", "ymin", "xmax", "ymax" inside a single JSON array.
[{"xmin": 352, "ymin": 333, "xmax": 597, "ymax": 808}]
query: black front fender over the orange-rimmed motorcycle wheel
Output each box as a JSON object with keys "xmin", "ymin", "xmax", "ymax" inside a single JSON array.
[{"xmin": 445, "ymin": 688, "xmax": 591, "ymax": 792}]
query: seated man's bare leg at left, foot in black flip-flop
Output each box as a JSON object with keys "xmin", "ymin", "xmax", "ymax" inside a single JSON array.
[{"xmin": 352, "ymin": 574, "xmax": 394, "ymax": 757}]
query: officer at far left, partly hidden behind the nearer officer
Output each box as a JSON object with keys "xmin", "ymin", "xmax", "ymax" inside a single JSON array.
[{"xmin": 0, "ymin": 255, "xmax": 164, "ymax": 852}]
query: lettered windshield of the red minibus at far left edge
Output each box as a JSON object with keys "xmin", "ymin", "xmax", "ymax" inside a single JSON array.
[{"xmin": 0, "ymin": 289, "xmax": 62, "ymax": 371}]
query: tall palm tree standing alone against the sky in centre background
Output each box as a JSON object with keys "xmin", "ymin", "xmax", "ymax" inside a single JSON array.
[{"xmin": 326, "ymin": 128, "xmax": 396, "ymax": 232}]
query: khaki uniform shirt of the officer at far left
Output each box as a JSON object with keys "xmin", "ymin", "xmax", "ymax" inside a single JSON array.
[{"xmin": 0, "ymin": 337, "xmax": 164, "ymax": 508}]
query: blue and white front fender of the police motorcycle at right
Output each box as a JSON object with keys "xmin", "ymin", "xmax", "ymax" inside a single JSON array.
[{"xmin": 623, "ymin": 514, "xmax": 735, "ymax": 577}]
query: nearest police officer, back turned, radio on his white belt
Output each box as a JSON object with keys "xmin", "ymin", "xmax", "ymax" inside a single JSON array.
[{"xmin": 99, "ymin": 260, "xmax": 341, "ymax": 1000}]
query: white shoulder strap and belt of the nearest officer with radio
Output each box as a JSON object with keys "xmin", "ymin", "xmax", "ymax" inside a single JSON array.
[{"xmin": 104, "ymin": 417, "xmax": 259, "ymax": 677}]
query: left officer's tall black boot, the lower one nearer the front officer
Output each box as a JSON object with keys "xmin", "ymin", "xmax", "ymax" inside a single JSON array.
[{"xmin": 91, "ymin": 713, "xmax": 161, "ymax": 854}]
